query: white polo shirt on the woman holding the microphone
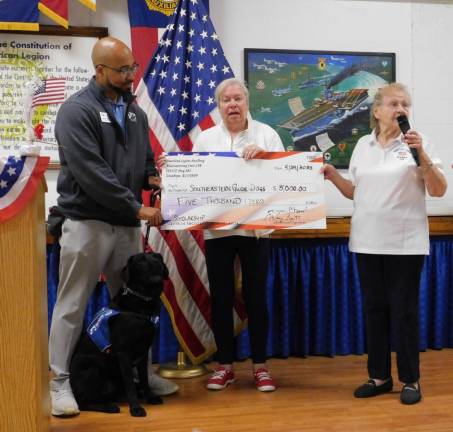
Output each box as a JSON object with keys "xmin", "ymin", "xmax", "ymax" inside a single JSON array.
[{"xmin": 349, "ymin": 131, "xmax": 442, "ymax": 255}]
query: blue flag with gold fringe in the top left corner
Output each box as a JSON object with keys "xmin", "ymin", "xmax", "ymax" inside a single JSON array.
[{"xmin": 0, "ymin": 0, "xmax": 39, "ymax": 31}]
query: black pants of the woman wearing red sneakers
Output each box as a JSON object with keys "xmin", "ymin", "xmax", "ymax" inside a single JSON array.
[{"xmin": 205, "ymin": 236, "xmax": 270, "ymax": 364}]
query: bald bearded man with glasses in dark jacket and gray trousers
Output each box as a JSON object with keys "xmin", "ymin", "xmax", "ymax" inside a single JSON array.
[{"xmin": 49, "ymin": 37, "xmax": 178, "ymax": 416}]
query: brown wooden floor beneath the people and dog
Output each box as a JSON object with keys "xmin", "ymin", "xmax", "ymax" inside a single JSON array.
[{"xmin": 50, "ymin": 349, "xmax": 453, "ymax": 432}]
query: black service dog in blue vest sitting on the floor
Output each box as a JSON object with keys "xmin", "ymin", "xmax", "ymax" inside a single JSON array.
[{"xmin": 69, "ymin": 253, "xmax": 168, "ymax": 417}]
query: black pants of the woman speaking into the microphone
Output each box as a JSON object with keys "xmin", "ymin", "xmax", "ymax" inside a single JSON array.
[{"xmin": 357, "ymin": 254, "xmax": 424, "ymax": 383}]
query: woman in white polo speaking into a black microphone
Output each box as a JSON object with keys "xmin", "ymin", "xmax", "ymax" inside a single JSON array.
[{"xmin": 323, "ymin": 83, "xmax": 447, "ymax": 404}]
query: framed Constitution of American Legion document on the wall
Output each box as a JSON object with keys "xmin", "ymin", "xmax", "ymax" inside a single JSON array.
[{"xmin": 0, "ymin": 26, "xmax": 108, "ymax": 168}]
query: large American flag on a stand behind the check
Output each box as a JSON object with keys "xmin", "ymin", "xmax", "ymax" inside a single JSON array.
[{"xmin": 129, "ymin": 0, "xmax": 246, "ymax": 363}]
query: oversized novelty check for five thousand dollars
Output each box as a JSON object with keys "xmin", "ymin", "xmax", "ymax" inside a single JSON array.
[{"xmin": 162, "ymin": 152, "xmax": 326, "ymax": 230}]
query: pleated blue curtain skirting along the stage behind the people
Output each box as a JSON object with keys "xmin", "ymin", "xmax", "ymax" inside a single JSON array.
[{"xmin": 47, "ymin": 236, "xmax": 453, "ymax": 363}]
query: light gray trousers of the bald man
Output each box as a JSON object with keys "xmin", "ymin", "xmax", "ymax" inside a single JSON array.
[{"xmin": 49, "ymin": 219, "xmax": 142, "ymax": 389}]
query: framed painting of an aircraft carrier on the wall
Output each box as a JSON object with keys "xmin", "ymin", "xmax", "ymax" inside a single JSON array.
[{"xmin": 244, "ymin": 48, "xmax": 395, "ymax": 168}]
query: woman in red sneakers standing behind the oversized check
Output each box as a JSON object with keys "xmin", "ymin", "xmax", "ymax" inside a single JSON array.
[{"xmin": 158, "ymin": 78, "xmax": 285, "ymax": 391}]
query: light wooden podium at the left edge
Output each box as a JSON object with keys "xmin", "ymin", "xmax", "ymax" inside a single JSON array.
[{"xmin": 0, "ymin": 178, "xmax": 50, "ymax": 432}]
